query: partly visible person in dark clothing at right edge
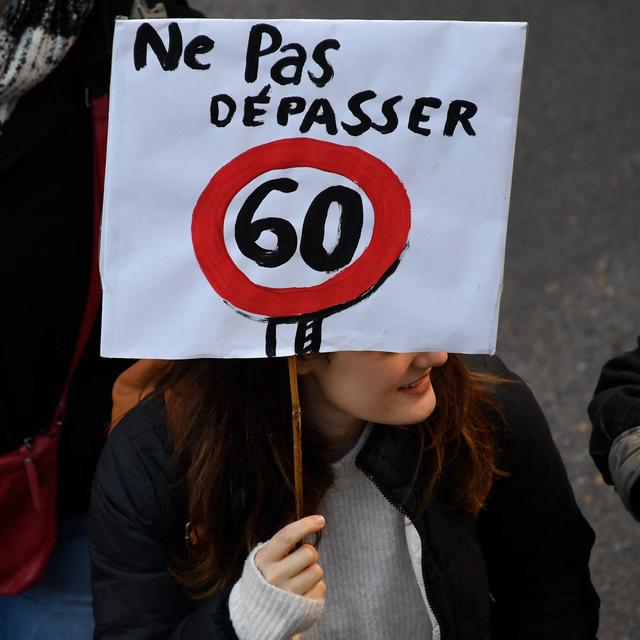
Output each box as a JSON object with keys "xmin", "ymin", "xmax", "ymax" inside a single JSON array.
[{"xmin": 588, "ymin": 337, "xmax": 640, "ymax": 521}]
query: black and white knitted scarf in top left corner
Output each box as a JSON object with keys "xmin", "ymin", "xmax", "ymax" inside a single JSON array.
[{"xmin": 0, "ymin": 0, "xmax": 93, "ymax": 134}]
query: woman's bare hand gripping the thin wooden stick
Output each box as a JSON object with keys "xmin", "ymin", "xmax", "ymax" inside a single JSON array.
[{"xmin": 256, "ymin": 516, "xmax": 327, "ymax": 600}]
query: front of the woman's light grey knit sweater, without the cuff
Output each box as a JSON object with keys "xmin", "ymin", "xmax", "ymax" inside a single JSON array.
[{"xmin": 302, "ymin": 425, "xmax": 431, "ymax": 640}]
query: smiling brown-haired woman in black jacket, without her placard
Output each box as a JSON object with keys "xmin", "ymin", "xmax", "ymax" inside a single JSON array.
[{"xmin": 91, "ymin": 351, "xmax": 598, "ymax": 640}]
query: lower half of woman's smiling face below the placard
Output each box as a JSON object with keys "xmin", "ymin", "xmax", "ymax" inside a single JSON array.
[{"xmin": 298, "ymin": 351, "xmax": 447, "ymax": 436}]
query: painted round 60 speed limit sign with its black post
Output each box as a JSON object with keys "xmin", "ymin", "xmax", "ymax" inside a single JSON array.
[{"xmin": 191, "ymin": 138, "xmax": 411, "ymax": 356}]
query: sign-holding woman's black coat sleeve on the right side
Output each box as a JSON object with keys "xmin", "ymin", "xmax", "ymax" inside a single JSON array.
[{"xmin": 478, "ymin": 358, "xmax": 599, "ymax": 640}]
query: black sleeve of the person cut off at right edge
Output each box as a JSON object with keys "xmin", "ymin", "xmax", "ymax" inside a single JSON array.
[{"xmin": 588, "ymin": 338, "xmax": 640, "ymax": 484}]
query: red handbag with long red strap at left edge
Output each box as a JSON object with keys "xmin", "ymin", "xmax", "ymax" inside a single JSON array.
[{"xmin": 0, "ymin": 96, "xmax": 108, "ymax": 595}]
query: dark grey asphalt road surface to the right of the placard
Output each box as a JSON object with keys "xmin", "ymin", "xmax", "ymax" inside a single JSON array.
[{"xmin": 192, "ymin": 0, "xmax": 640, "ymax": 640}]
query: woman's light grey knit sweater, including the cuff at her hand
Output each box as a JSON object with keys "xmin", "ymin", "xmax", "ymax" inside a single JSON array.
[{"xmin": 229, "ymin": 427, "xmax": 432, "ymax": 640}]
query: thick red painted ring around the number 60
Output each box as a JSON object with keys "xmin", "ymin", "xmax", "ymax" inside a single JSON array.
[{"xmin": 191, "ymin": 138, "xmax": 411, "ymax": 318}]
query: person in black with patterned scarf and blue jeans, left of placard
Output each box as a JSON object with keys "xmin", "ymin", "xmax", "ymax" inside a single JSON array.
[{"xmin": 0, "ymin": 0, "xmax": 199, "ymax": 640}]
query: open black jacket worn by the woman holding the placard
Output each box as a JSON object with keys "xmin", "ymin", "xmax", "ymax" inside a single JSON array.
[{"xmin": 90, "ymin": 358, "xmax": 599, "ymax": 640}]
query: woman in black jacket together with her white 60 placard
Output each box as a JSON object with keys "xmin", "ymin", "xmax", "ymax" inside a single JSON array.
[{"xmin": 91, "ymin": 20, "xmax": 598, "ymax": 640}]
